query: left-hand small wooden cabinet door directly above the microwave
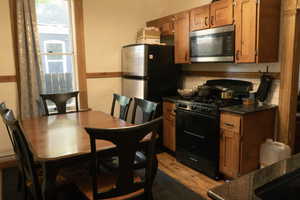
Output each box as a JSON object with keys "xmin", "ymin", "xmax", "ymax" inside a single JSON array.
[{"xmin": 190, "ymin": 5, "xmax": 210, "ymax": 31}]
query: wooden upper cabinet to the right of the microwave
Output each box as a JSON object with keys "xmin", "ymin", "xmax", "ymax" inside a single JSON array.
[{"xmin": 234, "ymin": 0, "xmax": 280, "ymax": 63}]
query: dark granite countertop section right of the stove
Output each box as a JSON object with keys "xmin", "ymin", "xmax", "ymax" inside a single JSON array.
[{"xmin": 220, "ymin": 104, "xmax": 277, "ymax": 115}]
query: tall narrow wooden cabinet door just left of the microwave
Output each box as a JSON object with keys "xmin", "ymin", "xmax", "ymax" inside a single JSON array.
[{"xmin": 174, "ymin": 12, "xmax": 190, "ymax": 64}]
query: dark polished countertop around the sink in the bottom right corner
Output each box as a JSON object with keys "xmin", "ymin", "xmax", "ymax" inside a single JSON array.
[{"xmin": 208, "ymin": 154, "xmax": 300, "ymax": 200}]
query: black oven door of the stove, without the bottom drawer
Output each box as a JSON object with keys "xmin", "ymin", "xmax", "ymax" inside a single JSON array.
[{"xmin": 176, "ymin": 109, "xmax": 220, "ymax": 161}]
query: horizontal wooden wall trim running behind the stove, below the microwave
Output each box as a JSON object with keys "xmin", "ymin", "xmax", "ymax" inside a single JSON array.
[{"xmin": 182, "ymin": 71, "xmax": 280, "ymax": 79}]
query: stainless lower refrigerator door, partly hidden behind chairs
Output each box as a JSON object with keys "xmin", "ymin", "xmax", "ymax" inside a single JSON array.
[{"xmin": 122, "ymin": 78, "xmax": 148, "ymax": 124}]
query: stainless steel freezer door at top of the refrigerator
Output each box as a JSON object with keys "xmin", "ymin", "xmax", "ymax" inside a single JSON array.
[{"xmin": 122, "ymin": 45, "xmax": 148, "ymax": 77}]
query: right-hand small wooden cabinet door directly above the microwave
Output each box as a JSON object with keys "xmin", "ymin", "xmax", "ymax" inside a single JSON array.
[{"xmin": 210, "ymin": 0, "xmax": 233, "ymax": 28}]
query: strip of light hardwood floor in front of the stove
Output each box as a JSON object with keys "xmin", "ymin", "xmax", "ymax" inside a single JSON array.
[{"xmin": 158, "ymin": 153, "xmax": 224, "ymax": 199}]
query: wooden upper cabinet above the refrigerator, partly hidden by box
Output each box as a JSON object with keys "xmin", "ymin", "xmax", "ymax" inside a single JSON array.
[{"xmin": 147, "ymin": 16, "xmax": 174, "ymax": 36}]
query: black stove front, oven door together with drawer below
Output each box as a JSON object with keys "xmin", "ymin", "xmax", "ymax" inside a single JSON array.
[{"xmin": 176, "ymin": 108, "xmax": 219, "ymax": 179}]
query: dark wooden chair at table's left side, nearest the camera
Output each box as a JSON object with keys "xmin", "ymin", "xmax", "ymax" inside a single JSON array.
[{"xmin": 3, "ymin": 110, "xmax": 87, "ymax": 200}]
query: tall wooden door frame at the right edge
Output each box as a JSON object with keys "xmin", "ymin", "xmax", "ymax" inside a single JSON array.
[{"xmin": 277, "ymin": 0, "xmax": 300, "ymax": 149}]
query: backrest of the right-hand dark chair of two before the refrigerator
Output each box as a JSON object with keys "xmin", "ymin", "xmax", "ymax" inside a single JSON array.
[{"xmin": 131, "ymin": 98, "xmax": 158, "ymax": 124}]
